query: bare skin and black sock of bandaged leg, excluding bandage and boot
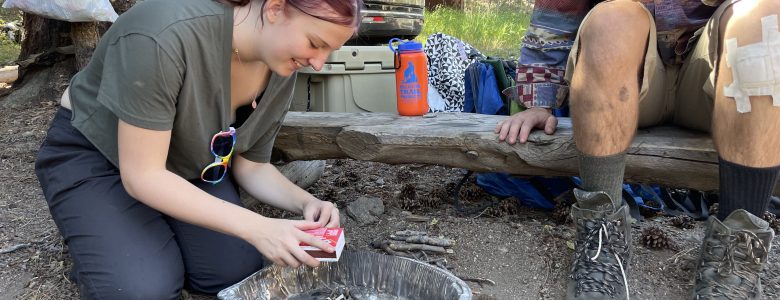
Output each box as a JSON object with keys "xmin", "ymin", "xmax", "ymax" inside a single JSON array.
[{"xmin": 712, "ymin": 0, "xmax": 780, "ymax": 220}]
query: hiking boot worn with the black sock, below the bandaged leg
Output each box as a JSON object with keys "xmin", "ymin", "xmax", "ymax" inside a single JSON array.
[{"xmin": 693, "ymin": 209, "xmax": 775, "ymax": 299}]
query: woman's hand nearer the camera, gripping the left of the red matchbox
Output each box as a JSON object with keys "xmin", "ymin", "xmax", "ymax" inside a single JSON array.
[{"xmin": 245, "ymin": 216, "xmax": 336, "ymax": 268}]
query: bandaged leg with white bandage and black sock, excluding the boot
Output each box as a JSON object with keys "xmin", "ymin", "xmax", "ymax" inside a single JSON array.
[{"xmin": 712, "ymin": 1, "xmax": 780, "ymax": 219}]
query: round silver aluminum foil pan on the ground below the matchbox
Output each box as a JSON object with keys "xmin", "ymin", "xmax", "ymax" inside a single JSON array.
[{"xmin": 217, "ymin": 251, "xmax": 471, "ymax": 300}]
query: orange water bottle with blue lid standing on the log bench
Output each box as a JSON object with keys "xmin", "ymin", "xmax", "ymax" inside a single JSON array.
[{"xmin": 389, "ymin": 38, "xmax": 428, "ymax": 116}]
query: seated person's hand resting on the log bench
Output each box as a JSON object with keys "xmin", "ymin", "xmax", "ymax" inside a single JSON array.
[{"xmin": 495, "ymin": 107, "xmax": 558, "ymax": 145}]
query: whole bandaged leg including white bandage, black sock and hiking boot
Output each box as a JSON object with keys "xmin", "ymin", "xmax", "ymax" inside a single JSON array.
[{"xmin": 682, "ymin": 0, "xmax": 780, "ymax": 299}]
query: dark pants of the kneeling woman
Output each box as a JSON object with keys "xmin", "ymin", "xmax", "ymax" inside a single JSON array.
[{"xmin": 35, "ymin": 108, "xmax": 263, "ymax": 299}]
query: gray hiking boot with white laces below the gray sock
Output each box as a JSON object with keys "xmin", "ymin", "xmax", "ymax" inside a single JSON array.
[{"xmin": 566, "ymin": 189, "xmax": 631, "ymax": 299}]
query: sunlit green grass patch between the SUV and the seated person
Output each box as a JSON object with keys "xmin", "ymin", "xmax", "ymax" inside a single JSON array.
[{"xmin": 417, "ymin": 5, "xmax": 531, "ymax": 58}]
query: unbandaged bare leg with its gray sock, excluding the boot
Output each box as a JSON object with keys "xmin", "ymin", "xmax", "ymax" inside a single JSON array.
[{"xmin": 570, "ymin": 1, "xmax": 650, "ymax": 207}]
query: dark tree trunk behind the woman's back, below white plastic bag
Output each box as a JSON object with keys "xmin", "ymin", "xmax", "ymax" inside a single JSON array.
[{"xmin": 0, "ymin": 0, "xmax": 136, "ymax": 107}]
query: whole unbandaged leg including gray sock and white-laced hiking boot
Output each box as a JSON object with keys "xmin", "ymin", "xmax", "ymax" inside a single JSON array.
[{"xmin": 567, "ymin": 1, "xmax": 654, "ymax": 299}]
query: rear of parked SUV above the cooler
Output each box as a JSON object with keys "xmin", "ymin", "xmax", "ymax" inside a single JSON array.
[{"xmin": 350, "ymin": 0, "xmax": 425, "ymax": 45}]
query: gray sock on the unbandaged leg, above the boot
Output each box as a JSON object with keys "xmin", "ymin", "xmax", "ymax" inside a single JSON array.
[{"xmin": 580, "ymin": 152, "xmax": 626, "ymax": 208}]
